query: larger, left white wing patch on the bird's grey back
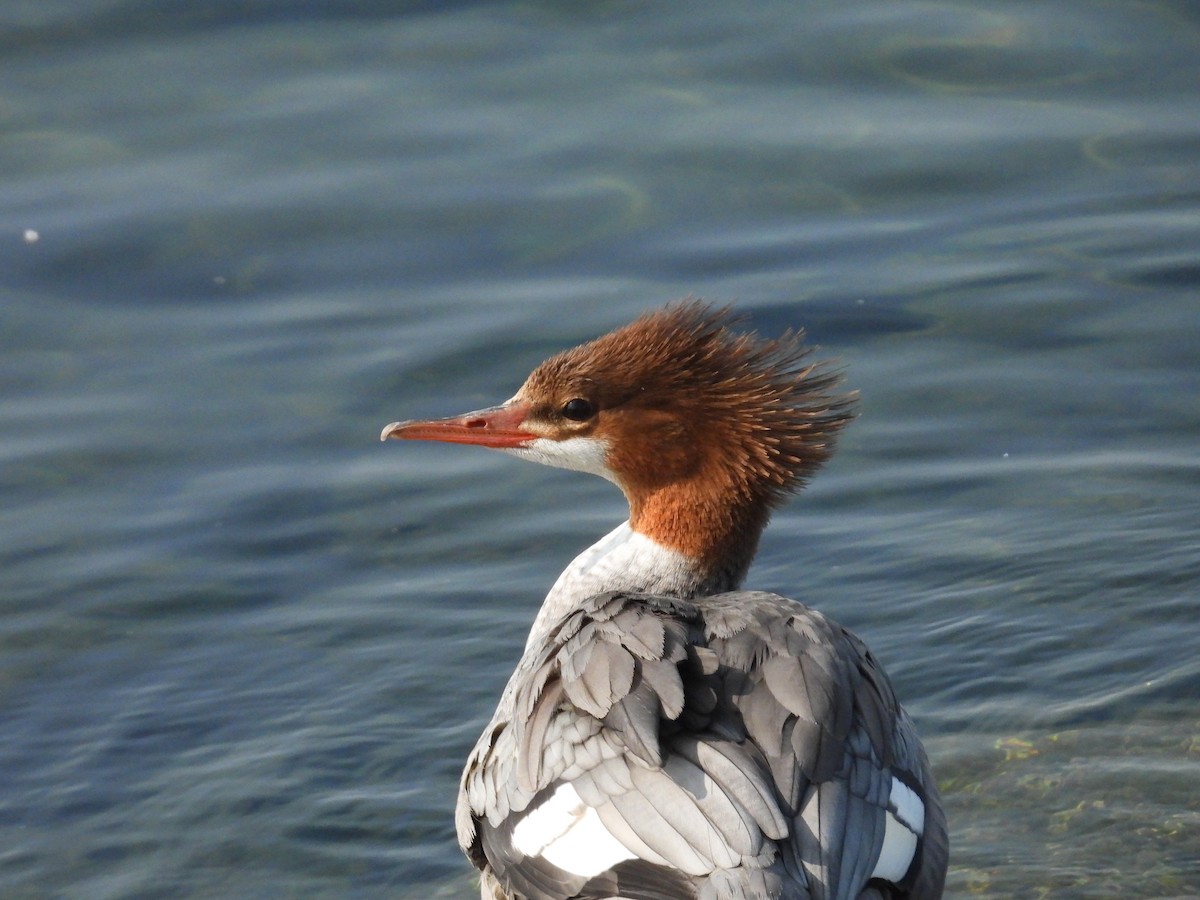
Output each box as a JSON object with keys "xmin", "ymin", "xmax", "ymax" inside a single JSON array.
[{"xmin": 512, "ymin": 785, "xmax": 636, "ymax": 878}]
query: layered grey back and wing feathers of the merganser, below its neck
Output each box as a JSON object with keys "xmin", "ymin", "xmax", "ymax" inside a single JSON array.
[{"xmin": 457, "ymin": 592, "xmax": 946, "ymax": 900}]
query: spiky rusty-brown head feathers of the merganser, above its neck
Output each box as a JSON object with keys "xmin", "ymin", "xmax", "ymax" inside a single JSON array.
[{"xmin": 522, "ymin": 301, "xmax": 854, "ymax": 506}]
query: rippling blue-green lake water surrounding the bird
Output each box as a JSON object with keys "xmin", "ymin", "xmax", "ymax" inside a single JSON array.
[{"xmin": 0, "ymin": 0, "xmax": 1200, "ymax": 900}]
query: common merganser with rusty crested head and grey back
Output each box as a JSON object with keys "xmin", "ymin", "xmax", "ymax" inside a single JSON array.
[{"xmin": 380, "ymin": 301, "xmax": 948, "ymax": 900}]
